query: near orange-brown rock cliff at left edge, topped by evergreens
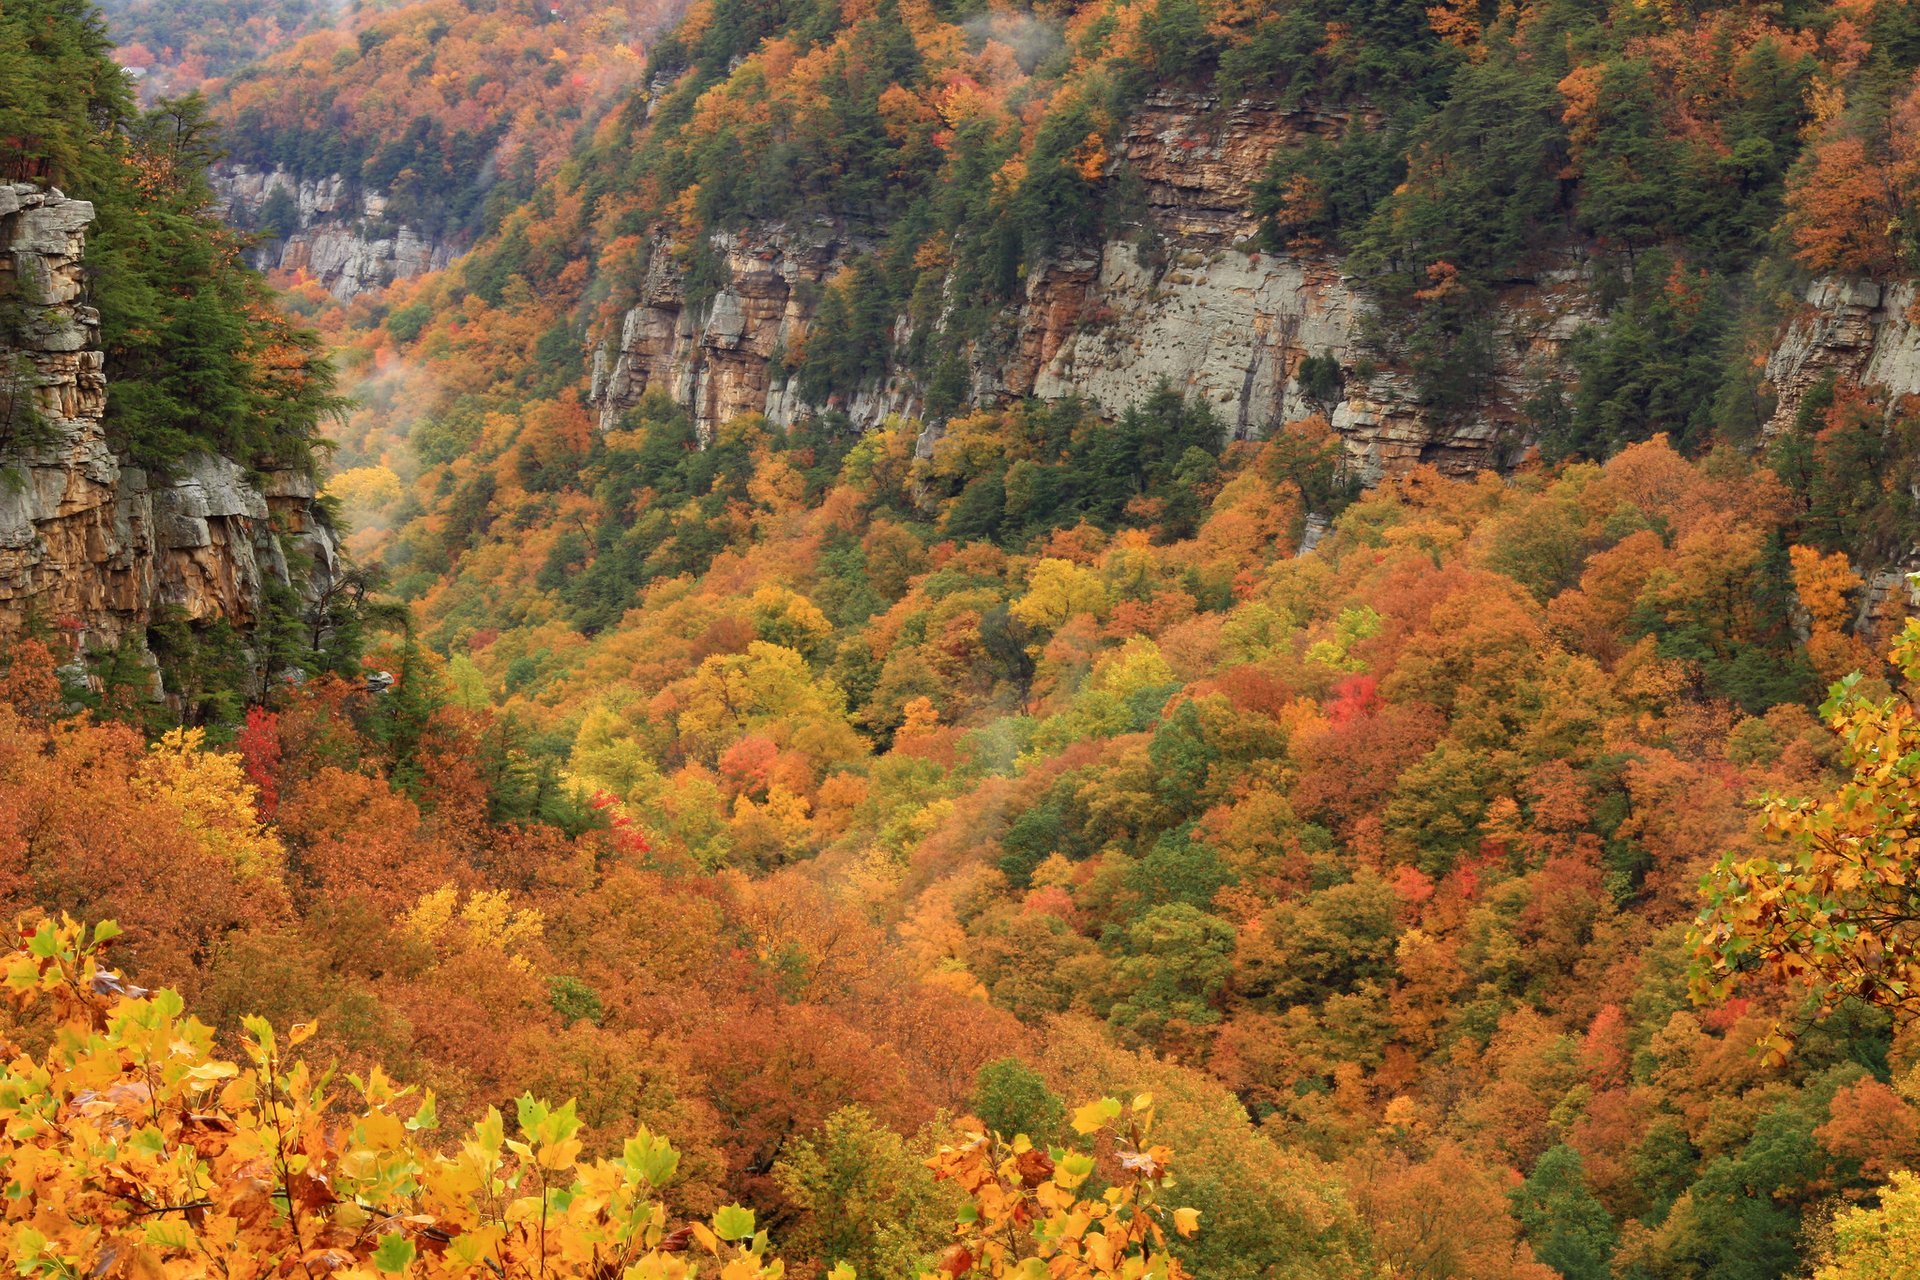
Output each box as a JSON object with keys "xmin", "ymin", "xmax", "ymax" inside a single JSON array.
[{"xmin": 0, "ymin": 186, "xmax": 338, "ymax": 667}]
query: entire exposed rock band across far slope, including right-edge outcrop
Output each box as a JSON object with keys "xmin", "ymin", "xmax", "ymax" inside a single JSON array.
[{"xmin": 589, "ymin": 92, "xmax": 1920, "ymax": 486}]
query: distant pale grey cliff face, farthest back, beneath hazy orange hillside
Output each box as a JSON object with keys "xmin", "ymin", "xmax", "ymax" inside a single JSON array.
[{"xmin": 215, "ymin": 165, "xmax": 455, "ymax": 301}]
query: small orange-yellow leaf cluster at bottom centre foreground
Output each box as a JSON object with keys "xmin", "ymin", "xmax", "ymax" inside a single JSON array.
[{"xmin": 922, "ymin": 1094, "xmax": 1200, "ymax": 1280}]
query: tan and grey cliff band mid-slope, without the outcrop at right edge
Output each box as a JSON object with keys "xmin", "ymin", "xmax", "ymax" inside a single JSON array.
[{"xmin": 593, "ymin": 94, "xmax": 1592, "ymax": 480}]
